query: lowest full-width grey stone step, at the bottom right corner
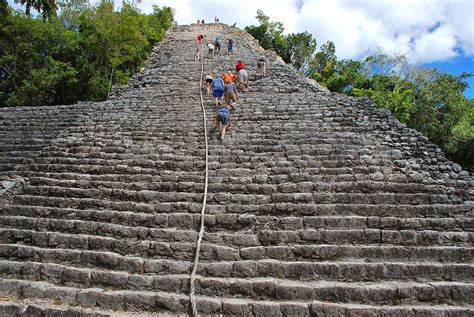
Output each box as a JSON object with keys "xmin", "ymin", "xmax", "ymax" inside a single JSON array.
[{"xmin": 0, "ymin": 279, "xmax": 474, "ymax": 317}]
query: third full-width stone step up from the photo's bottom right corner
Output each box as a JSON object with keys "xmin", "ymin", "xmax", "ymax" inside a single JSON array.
[{"xmin": 0, "ymin": 244, "xmax": 474, "ymax": 282}]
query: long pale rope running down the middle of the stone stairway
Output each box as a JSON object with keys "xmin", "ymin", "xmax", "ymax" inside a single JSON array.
[{"xmin": 189, "ymin": 44, "xmax": 209, "ymax": 317}]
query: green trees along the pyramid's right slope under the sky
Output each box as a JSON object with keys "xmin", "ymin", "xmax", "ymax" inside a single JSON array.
[{"xmin": 245, "ymin": 10, "xmax": 474, "ymax": 173}]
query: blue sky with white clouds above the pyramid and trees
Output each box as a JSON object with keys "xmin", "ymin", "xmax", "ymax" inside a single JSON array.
[{"xmin": 9, "ymin": 0, "xmax": 474, "ymax": 98}]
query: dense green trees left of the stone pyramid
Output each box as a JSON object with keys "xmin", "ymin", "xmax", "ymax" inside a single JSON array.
[{"xmin": 0, "ymin": 0, "xmax": 173, "ymax": 107}]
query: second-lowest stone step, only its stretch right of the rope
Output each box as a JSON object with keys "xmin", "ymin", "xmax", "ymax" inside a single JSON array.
[{"xmin": 196, "ymin": 277, "xmax": 474, "ymax": 305}]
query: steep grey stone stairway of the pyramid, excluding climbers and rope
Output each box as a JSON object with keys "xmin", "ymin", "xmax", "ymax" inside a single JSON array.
[{"xmin": 0, "ymin": 24, "xmax": 474, "ymax": 316}]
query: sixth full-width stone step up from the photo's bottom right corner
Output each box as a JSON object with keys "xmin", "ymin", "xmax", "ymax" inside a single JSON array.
[{"xmin": 2, "ymin": 204, "xmax": 474, "ymax": 232}]
